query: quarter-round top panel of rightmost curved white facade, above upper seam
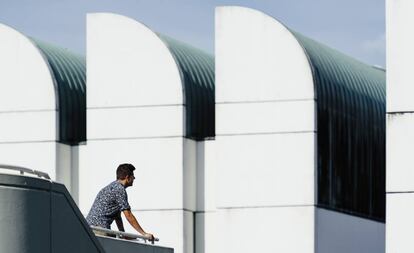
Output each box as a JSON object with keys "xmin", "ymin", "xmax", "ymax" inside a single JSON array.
[{"xmin": 216, "ymin": 6, "xmax": 314, "ymax": 103}]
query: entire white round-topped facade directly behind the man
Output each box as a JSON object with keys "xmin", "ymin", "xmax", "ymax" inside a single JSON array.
[{"xmin": 83, "ymin": 13, "xmax": 196, "ymax": 253}]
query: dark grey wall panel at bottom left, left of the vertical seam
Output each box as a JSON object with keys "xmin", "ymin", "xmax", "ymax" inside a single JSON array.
[{"xmin": 0, "ymin": 184, "xmax": 51, "ymax": 253}]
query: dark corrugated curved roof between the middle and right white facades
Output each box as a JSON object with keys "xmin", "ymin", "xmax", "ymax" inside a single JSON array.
[{"xmin": 158, "ymin": 34, "xmax": 215, "ymax": 140}]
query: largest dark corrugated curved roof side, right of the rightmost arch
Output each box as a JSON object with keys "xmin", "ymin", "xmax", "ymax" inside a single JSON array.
[{"xmin": 293, "ymin": 32, "xmax": 386, "ymax": 221}]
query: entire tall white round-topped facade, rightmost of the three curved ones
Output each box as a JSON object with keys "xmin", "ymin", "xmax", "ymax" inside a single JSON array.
[{"xmin": 215, "ymin": 7, "xmax": 316, "ymax": 253}]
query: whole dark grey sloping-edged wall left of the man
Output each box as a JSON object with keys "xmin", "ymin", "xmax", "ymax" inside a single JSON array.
[{"xmin": 0, "ymin": 175, "xmax": 105, "ymax": 253}]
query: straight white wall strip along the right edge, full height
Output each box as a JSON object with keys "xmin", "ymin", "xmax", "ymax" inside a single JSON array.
[{"xmin": 386, "ymin": 0, "xmax": 414, "ymax": 253}]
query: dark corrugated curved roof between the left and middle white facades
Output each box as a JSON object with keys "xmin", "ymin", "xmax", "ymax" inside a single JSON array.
[{"xmin": 31, "ymin": 38, "xmax": 86, "ymax": 145}]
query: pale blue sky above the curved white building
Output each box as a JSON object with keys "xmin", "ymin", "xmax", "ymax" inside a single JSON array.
[{"xmin": 0, "ymin": 0, "xmax": 385, "ymax": 66}]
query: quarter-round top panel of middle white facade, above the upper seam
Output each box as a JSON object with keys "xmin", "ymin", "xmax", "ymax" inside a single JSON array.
[{"xmin": 87, "ymin": 13, "xmax": 183, "ymax": 108}]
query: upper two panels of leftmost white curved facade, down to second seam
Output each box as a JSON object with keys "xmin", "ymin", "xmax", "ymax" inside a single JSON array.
[{"xmin": 0, "ymin": 24, "xmax": 56, "ymax": 143}]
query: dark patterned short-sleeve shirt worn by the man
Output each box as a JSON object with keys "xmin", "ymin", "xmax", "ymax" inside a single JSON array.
[{"xmin": 86, "ymin": 181, "xmax": 131, "ymax": 229}]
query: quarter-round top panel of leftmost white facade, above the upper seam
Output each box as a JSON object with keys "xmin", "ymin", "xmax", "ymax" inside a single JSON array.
[{"xmin": 0, "ymin": 24, "xmax": 56, "ymax": 112}]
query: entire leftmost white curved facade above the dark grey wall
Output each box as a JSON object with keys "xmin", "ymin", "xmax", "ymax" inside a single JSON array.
[{"xmin": 0, "ymin": 24, "xmax": 72, "ymax": 191}]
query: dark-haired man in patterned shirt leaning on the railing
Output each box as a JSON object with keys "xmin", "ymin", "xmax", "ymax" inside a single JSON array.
[{"xmin": 86, "ymin": 163, "xmax": 154, "ymax": 241}]
